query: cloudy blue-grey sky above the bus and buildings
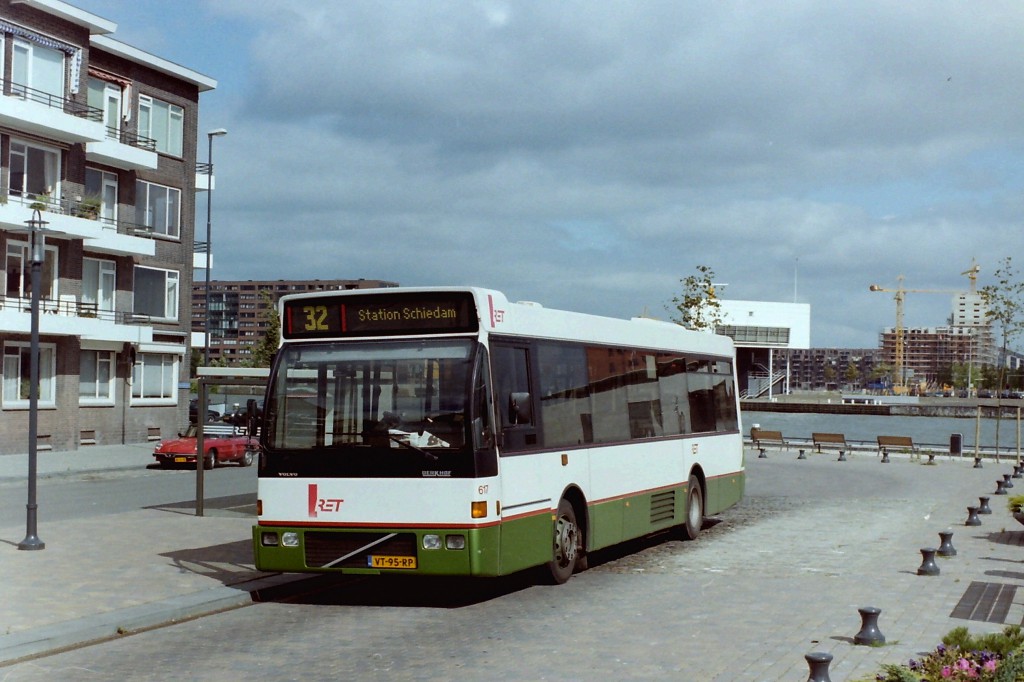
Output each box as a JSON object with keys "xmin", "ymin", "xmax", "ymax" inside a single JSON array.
[{"xmin": 72, "ymin": 0, "xmax": 1024, "ymax": 347}]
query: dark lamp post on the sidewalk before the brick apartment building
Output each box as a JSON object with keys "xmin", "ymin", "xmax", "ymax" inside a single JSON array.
[{"xmin": 17, "ymin": 209, "xmax": 46, "ymax": 550}]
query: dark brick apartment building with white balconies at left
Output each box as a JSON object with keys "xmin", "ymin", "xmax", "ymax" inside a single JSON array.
[{"xmin": 0, "ymin": 0, "xmax": 216, "ymax": 453}]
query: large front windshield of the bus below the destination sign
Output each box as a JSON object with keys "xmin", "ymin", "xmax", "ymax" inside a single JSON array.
[{"xmin": 265, "ymin": 339, "xmax": 474, "ymax": 473}]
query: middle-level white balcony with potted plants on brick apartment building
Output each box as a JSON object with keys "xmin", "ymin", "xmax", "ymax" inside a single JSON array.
[{"xmin": 0, "ymin": 195, "xmax": 157, "ymax": 256}]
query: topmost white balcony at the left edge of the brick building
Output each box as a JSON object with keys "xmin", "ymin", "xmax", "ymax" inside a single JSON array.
[{"xmin": 0, "ymin": 80, "xmax": 106, "ymax": 143}]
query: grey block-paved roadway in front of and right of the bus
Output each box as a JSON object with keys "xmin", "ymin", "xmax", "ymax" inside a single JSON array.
[{"xmin": 0, "ymin": 453, "xmax": 1012, "ymax": 682}]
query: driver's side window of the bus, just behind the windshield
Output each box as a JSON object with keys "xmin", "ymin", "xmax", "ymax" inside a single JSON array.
[{"xmin": 490, "ymin": 343, "xmax": 538, "ymax": 453}]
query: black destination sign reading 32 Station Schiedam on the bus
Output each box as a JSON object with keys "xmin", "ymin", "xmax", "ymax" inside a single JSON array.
[{"xmin": 282, "ymin": 292, "xmax": 478, "ymax": 339}]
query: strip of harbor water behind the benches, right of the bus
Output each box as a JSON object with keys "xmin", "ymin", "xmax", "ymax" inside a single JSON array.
[{"xmin": 741, "ymin": 411, "xmax": 1022, "ymax": 454}]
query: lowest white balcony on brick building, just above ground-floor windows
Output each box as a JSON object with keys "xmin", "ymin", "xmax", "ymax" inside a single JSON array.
[{"xmin": 0, "ymin": 296, "xmax": 153, "ymax": 343}]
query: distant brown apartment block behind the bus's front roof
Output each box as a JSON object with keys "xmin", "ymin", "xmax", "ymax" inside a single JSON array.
[{"xmin": 191, "ymin": 280, "xmax": 398, "ymax": 367}]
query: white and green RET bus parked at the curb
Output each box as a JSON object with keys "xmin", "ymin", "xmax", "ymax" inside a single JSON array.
[{"xmin": 253, "ymin": 287, "xmax": 745, "ymax": 584}]
